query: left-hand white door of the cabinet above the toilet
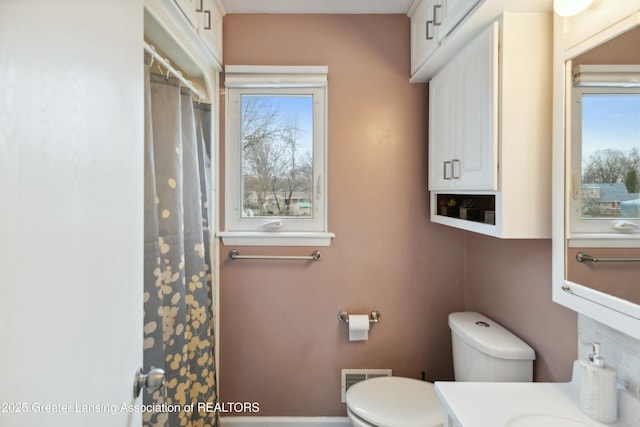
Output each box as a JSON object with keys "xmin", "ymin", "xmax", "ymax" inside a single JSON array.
[{"xmin": 429, "ymin": 64, "xmax": 456, "ymax": 190}]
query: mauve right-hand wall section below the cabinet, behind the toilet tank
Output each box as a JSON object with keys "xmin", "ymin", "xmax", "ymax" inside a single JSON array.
[{"xmin": 465, "ymin": 233, "xmax": 578, "ymax": 381}]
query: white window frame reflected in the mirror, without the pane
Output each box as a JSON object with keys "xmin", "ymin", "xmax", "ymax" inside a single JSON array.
[{"xmin": 566, "ymin": 83, "xmax": 640, "ymax": 247}]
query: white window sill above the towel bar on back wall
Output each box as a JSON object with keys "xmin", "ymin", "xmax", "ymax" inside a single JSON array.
[{"xmin": 217, "ymin": 231, "xmax": 336, "ymax": 246}]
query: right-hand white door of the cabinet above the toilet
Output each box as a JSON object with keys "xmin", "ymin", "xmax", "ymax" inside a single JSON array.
[{"xmin": 452, "ymin": 23, "xmax": 499, "ymax": 190}]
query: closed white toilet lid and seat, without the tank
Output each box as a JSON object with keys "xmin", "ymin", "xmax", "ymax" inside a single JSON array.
[{"xmin": 347, "ymin": 377, "xmax": 444, "ymax": 427}]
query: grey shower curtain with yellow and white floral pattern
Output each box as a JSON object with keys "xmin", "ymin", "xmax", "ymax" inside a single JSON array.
[{"xmin": 143, "ymin": 58, "xmax": 218, "ymax": 427}]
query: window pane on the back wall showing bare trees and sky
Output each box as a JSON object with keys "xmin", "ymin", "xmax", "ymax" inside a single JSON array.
[{"xmin": 241, "ymin": 95, "xmax": 313, "ymax": 218}]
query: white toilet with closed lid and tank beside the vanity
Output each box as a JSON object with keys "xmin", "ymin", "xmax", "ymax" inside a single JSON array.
[{"xmin": 346, "ymin": 312, "xmax": 536, "ymax": 427}]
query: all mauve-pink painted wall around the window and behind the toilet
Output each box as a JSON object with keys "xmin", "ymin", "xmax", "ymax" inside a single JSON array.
[{"xmin": 219, "ymin": 14, "xmax": 576, "ymax": 416}]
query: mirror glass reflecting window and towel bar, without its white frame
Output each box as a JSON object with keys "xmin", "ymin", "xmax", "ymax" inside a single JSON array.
[{"xmin": 566, "ymin": 27, "xmax": 640, "ymax": 304}]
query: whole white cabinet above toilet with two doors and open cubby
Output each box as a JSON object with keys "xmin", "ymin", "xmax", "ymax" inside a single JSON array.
[{"xmin": 429, "ymin": 12, "xmax": 552, "ymax": 238}]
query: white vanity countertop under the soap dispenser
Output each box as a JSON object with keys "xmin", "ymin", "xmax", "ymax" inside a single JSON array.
[{"xmin": 436, "ymin": 381, "xmax": 640, "ymax": 427}]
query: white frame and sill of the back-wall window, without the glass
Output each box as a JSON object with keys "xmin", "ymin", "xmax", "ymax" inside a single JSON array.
[{"xmin": 219, "ymin": 65, "xmax": 335, "ymax": 246}]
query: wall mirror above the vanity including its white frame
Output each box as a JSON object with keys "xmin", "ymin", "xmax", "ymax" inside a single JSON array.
[{"xmin": 553, "ymin": 6, "xmax": 640, "ymax": 338}]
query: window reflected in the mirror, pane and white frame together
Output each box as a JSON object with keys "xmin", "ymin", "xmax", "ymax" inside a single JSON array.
[{"xmin": 569, "ymin": 66, "xmax": 640, "ymax": 243}]
